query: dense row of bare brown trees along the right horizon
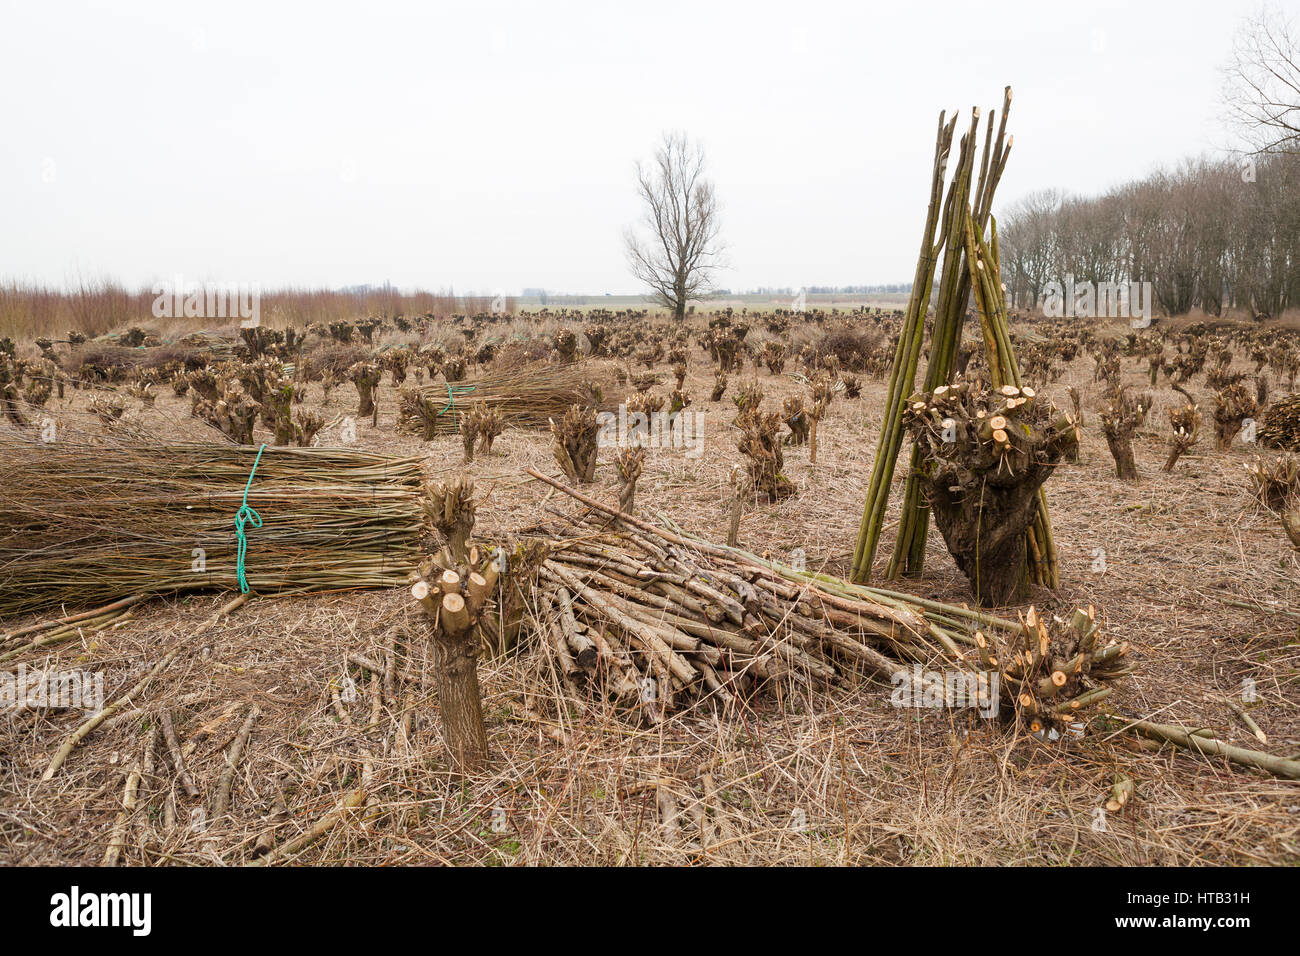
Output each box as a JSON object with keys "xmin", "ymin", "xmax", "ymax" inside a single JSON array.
[{"xmin": 998, "ymin": 153, "xmax": 1300, "ymax": 316}]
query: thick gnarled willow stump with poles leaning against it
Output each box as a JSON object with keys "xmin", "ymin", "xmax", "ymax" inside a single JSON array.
[{"xmin": 905, "ymin": 381, "xmax": 1078, "ymax": 605}]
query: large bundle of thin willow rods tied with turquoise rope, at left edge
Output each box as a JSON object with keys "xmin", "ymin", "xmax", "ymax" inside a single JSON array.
[{"xmin": 0, "ymin": 440, "xmax": 423, "ymax": 618}]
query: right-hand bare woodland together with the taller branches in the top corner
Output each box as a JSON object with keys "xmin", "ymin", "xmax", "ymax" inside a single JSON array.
[{"xmin": 1000, "ymin": 7, "xmax": 1300, "ymax": 317}]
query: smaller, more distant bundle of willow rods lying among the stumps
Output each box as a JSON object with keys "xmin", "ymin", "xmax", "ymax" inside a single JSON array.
[{"xmin": 398, "ymin": 363, "xmax": 612, "ymax": 441}]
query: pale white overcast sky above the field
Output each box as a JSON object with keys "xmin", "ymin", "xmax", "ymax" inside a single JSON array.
[{"xmin": 0, "ymin": 0, "xmax": 1279, "ymax": 294}]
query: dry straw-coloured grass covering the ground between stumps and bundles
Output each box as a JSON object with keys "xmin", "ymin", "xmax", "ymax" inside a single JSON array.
[{"xmin": 0, "ymin": 316, "xmax": 1300, "ymax": 866}]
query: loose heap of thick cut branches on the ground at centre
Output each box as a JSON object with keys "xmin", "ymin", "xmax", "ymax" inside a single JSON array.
[{"xmin": 529, "ymin": 470, "xmax": 1119, "ymax": 719}]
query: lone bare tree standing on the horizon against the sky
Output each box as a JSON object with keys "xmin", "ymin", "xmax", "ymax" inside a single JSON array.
[{"xmin": 625, "ymin": 133, "xmax": 722, "ymax": 320}]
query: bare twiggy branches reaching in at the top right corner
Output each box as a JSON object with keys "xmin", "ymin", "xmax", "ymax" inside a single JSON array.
[{"xmin": 1225, "ymin": 8, "xmax": 1300, "ymax": 153}]
